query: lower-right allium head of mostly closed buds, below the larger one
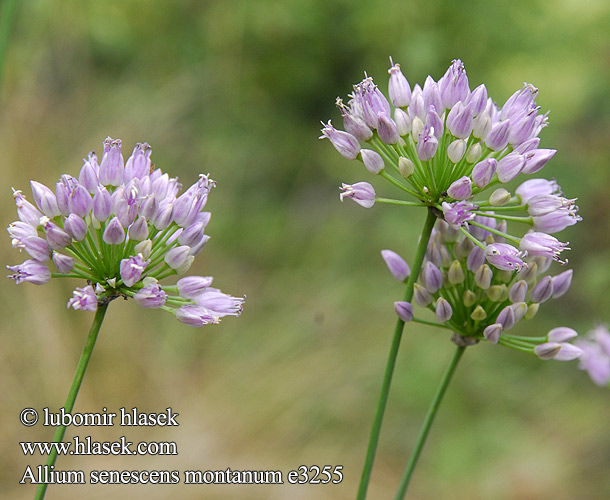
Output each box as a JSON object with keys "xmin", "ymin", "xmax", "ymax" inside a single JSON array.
[{"xmin": 382, "ymin": 220, "xmax": 582, "ymax": 361}]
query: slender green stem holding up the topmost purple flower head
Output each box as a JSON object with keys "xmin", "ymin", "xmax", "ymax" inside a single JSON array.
[{"xmin": 356, "ymin": 209, "xmax": 436, "ymax": 500}]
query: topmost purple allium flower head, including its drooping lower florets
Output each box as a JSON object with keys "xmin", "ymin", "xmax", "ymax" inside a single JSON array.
[{"xmin": 321, "ymin": 60, "xmax": 581, "ymax": 271}]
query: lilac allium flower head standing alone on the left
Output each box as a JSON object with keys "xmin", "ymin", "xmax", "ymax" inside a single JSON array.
[{"xmin": 8, "ymin": 138, "xmax": 244, "ymax": 326}]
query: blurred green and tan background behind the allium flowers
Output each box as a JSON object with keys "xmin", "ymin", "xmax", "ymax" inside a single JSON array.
[{"xmin": 0, "ymin": 0, "xmax": 610, "ymax": 500}]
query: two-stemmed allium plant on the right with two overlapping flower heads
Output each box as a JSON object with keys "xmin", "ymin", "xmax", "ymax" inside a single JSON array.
[{"xmin": 320, "ymin": 60, "xmax": 583, "ymax": 499}]
